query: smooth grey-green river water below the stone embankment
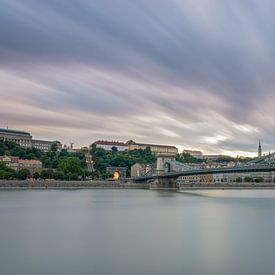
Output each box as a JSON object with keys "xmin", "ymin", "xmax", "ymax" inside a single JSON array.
[{"xmin": 0, "ymin": 190, "xmax": 275, "ymax": 275}]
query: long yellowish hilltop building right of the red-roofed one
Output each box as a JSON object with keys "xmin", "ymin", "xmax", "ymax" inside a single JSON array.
[{"xmin": 126, "ymin": 140, "xmax": 178, "ymax": 154}]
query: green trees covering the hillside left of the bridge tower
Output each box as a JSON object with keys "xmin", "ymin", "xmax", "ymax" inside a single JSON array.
[{"xmin": 0, "ymin": 141, "xmax": 156, "ymax": 180}]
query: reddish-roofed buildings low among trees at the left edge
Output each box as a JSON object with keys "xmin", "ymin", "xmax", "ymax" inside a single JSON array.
[{"xmin": 0, "ymin": 156, "xmax": 42, "ymax": 174}]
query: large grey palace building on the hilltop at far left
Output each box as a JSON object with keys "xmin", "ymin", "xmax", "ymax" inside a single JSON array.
[{"xmin": 0, "ymin": 128, "xmax": 62, "ymax": 152}]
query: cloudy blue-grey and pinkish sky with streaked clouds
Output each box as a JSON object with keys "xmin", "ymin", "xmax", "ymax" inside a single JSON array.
[{"xmin": 0, "ymin": 0, "xmax": 275, "ymax": 156}]
